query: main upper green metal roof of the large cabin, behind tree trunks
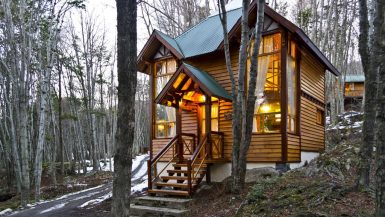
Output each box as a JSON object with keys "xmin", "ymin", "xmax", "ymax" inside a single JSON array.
[{"xmin": 138, "ymin": 0, "xmax": 340, "ymax": 76}]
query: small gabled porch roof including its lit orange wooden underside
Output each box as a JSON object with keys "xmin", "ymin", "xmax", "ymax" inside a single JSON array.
[{"xmin": 155, "ymin": 63, "xmax": 232, "ymax": 107}]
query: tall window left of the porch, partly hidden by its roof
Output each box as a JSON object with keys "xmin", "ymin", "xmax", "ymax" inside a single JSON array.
[{"xmin": 155, "ymin": 59, "xmax": 176, "ymax": 138}]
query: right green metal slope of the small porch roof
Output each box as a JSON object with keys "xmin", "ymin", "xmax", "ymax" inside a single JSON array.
[{"xmin": 183, "ymin": 63, "xmax": 232, "ymax": 100}]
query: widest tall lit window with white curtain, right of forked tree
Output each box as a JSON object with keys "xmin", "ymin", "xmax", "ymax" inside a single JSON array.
[{"xmin": 247, "ymin": 33, "xmax": 281, "ymax": 133}]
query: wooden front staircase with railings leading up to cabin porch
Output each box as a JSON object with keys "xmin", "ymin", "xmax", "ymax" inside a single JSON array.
[{"xmin": 148, "ymin": 132, "xmax": 224, "ymax": 197}]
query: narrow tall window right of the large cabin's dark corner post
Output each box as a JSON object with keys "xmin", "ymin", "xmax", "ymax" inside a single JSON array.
[{"xmin": 286, "ymin": 41, "xmax": 298, "ymax": 133}]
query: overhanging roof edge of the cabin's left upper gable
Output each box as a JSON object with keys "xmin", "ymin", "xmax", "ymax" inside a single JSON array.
[{"xmin": 137, "ymin": 30, "xmax": 184, "ymax": 74}]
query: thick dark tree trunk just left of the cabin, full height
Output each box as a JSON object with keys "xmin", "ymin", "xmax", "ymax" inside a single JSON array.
[{"xmin": 112, "ymin": 0, "xmax": 137, "ymax": 217}]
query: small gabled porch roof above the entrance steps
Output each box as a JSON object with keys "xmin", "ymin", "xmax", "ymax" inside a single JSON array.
[{"xmin": 155, "ymin": 63, "xmax": 232, "ymax": 104}]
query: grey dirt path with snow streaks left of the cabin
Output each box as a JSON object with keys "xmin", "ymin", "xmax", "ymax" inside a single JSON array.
[{"xmin": 9, "ymin": 157, "xmax": 148, "ymax": 217}]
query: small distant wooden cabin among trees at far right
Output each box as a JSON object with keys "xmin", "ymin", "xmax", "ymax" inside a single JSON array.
[{"xmin": 344, "ymin": 75, "xmax": 365, "ymax": 111}]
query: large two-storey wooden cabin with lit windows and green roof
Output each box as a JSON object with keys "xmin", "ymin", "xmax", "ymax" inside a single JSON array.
[{"xmin": 138, "ymin": 1, "xmax": 339, "ymax": 196}]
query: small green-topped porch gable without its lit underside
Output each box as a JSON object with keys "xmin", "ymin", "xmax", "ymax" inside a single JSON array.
[{"xmin": 155, "ymin": 63, "xmax": 232, "ymax": 104}]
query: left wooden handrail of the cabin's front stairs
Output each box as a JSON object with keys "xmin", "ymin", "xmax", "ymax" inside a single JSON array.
[{"xmin": 147, "ymin": 135, "xmax": 179, "ymax": 189}]
